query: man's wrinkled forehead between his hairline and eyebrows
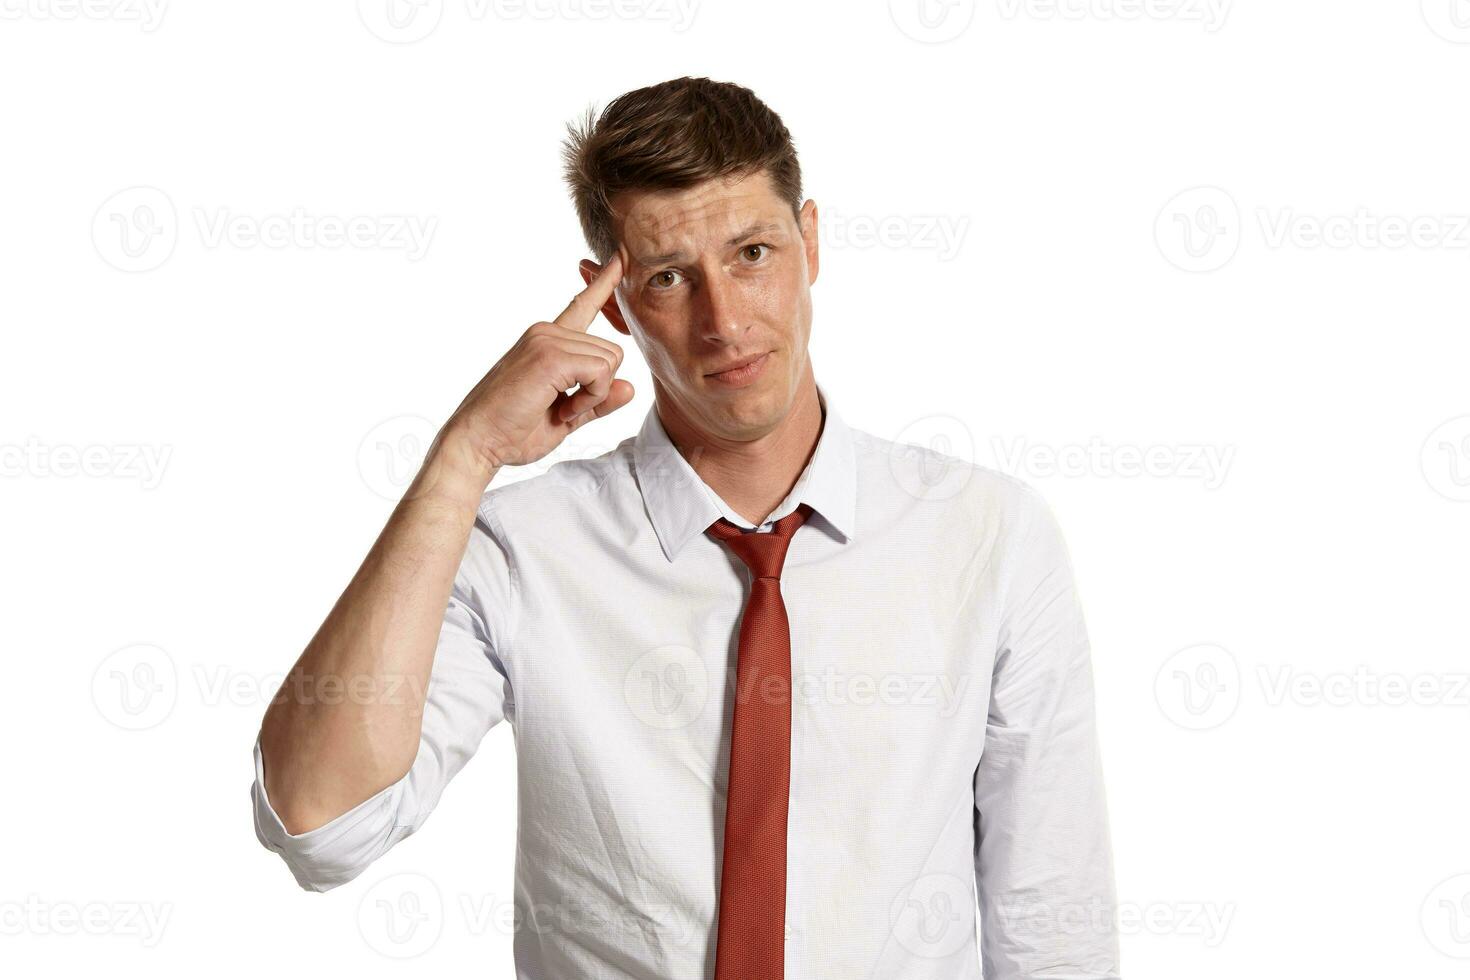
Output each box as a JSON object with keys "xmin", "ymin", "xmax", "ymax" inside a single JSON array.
[{"xmin": 613, "ymin": 173, "xmax": 795, "ymax": 262}]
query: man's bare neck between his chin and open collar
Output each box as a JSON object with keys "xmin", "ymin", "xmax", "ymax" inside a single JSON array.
[{"xmin": 656, "ymin": 369, "xmax": 826, "ymax": 525}]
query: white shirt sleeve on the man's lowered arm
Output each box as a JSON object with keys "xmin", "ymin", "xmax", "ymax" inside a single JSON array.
[{"xmin": 975, "ymin": 488, "xmax": 1119, "ymax": 980}]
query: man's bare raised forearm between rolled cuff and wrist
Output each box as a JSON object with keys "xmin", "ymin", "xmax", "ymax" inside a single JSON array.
[{"xmin": 260, "ymin": 438, "xmax": 497, "ymax": 835}]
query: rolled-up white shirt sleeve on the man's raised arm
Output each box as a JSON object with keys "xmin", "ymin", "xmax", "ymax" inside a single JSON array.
[{"xmin": 250, "ymin": 504, "xmax": 513, "ymax": 892}]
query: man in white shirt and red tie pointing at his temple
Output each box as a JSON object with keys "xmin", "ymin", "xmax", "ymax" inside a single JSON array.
[{"xmin": 253, "ymin": 78, "xmax": 1117, "ymax": 980}]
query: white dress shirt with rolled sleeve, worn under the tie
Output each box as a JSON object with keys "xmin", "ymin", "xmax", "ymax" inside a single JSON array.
[{"xmin": 251, "ymin": 385, "xmax": 1117, "ymax": 980}]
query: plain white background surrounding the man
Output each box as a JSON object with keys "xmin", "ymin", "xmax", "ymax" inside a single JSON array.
[{"xmin": 0, "ymin": 0, "xmax": 1470, "ymax": 980}]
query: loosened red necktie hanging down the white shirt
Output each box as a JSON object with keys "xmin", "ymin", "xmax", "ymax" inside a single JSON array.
[{"xmin": 709, "ymin": 504, "xmax": 811, "ymax": 980}]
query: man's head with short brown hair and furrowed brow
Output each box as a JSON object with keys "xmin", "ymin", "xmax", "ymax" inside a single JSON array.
[{"xmin": 564, "ymin": 78, "xmax": 817, "ymax": 441}]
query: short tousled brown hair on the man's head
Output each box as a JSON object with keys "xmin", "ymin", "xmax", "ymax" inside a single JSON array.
[{"xmin": 562, "ymin": 75, "xmax": 801, "ymax": 262}]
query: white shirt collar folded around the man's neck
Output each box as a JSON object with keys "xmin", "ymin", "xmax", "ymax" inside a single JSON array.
[{"xmin": 634, "ymin": 383, "xmax": 857, "ymax": 561}]
